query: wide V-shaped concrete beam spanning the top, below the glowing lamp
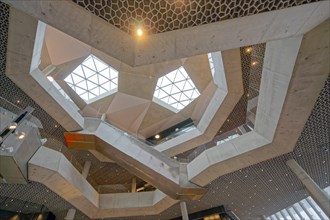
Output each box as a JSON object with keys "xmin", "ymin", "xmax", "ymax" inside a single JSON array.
[{"xmin": 4, "ymin": 0, "xmax": 329, "ymax": 66}]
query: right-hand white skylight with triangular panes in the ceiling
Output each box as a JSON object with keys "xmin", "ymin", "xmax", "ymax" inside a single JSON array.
[{"xmin": 154, "ymin": 67, "xmax": 200, "ymax": 111}]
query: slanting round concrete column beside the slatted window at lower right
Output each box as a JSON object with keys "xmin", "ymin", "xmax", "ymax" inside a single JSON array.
[{"xmin": 286, "ymin": 159, "xmax": 330, "ymax": 217}]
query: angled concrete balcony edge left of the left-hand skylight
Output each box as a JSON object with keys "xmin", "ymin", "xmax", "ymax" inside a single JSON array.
[{"xmin": 6, "ymin": 8, "xmax": 83, "ymax": 131}]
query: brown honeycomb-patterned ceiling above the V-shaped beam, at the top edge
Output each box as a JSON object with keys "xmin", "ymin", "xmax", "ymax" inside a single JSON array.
[{"xmin": 73, "ymin": 0, "xmax": 319, "ymax": 34}]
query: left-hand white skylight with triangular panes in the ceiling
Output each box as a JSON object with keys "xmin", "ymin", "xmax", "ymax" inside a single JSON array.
[{"xmin": 65, "ymin": 55, "xmax": 118, "ymax": 101}]
